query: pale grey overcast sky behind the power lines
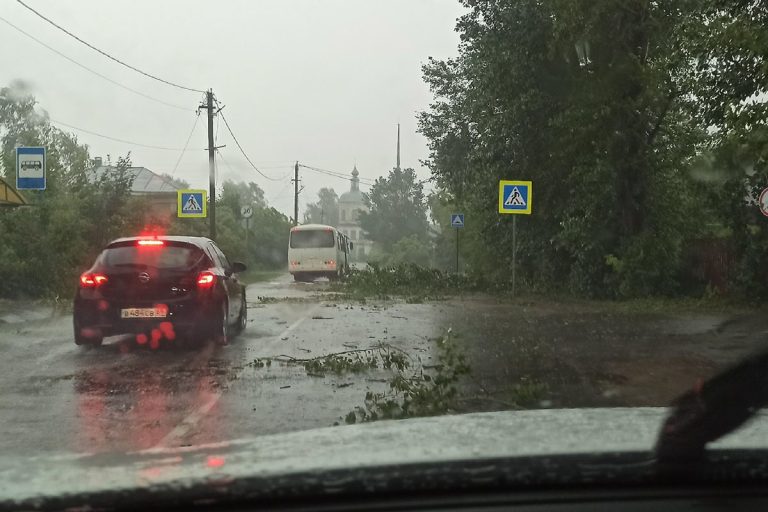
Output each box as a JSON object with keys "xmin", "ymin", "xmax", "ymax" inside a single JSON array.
[{"xmin": 0, "ymin": 0, "xmax": 463, "ymax": 214}]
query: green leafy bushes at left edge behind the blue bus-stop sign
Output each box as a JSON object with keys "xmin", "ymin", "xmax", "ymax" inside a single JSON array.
[{"xmin": 0, "ymin": 83, "xmax": 144, "ymax": 298}]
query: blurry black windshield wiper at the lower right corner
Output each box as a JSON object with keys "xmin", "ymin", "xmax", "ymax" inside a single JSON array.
[{"xmin": 655, "ymin": 350, "xmax": 768, "ymax": 463}]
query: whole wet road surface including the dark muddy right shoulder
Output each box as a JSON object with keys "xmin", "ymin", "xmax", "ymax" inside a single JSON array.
[{"xmin": 0, "ymin": 280, "xmax": 768, "ymax": 456}]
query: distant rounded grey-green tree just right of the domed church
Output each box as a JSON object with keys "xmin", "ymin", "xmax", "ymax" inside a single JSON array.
[{"xmin": 360, "ymin": 168, "xmax": 428, "ymax": 251}]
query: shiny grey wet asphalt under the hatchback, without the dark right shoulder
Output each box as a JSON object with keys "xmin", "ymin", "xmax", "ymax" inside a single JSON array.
[{"xmin": 0, "ymin": 274, "xmax": 444, "ymax": 455}]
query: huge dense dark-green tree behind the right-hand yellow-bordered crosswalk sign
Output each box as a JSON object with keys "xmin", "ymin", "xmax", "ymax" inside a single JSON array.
[{"xmin": 419, "ymin": 0, "xmax": 706, "ymax": 296}]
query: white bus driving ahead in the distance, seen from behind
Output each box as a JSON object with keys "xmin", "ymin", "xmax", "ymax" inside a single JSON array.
[{"xmin": 288, "ymin": 224, "xmax": 353, "ymax": 281}]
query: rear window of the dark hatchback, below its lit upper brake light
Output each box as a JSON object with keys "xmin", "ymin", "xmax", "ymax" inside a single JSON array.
[{"xmin": 101, "ymin": 245, "xmax": 204, "ymax": 268}]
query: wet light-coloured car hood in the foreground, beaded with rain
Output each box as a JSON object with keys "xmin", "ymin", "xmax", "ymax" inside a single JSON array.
[{"xmin": 0, "ymin": 408, "xmax": 768, "ymax": 506}]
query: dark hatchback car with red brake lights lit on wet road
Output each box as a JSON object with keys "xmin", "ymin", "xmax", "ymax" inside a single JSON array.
[{"xmin": 73, "ymin": 236, "xmax": 248, "ymax": 347}]
